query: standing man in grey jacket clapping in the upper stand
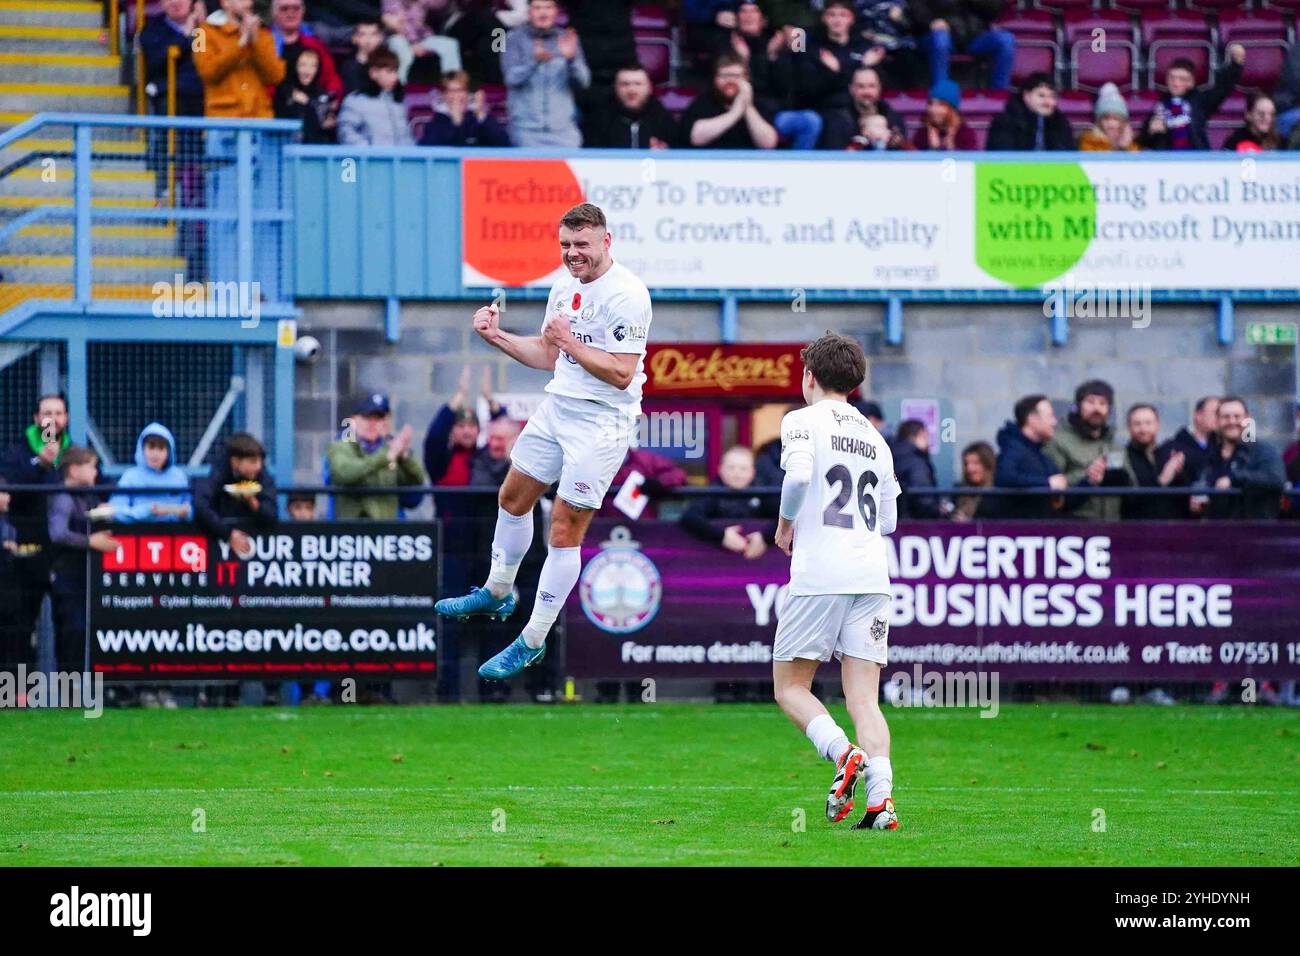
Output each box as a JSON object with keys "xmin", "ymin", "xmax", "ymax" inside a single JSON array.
[{"xmin": 501, "ymin": 0, "xmax": 592, "ymax": 148}]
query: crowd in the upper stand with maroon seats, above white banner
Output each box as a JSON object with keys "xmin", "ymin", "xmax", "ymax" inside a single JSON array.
[{"xmin": 139, "ymin": 0, "xmax": 1300, "ymax": 151}]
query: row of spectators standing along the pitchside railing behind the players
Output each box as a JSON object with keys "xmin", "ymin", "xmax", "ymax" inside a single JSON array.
[{"xmin": 0, "ymin": 369, "xmax": 1300, "ymax": 686}]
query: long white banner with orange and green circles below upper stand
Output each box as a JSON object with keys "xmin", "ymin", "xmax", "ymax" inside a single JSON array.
[{"xmin": 462, "ymin": 153, "xmax": 1300, "ymax": 291}]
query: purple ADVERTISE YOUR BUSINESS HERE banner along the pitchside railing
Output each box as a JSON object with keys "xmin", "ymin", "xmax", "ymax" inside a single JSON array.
[{"xmin": 566, "ymin": 520, "xmax": 1300, "ymax": 682}]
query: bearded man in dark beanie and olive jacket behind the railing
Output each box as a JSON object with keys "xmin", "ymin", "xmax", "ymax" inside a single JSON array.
[{"xmin": 1043, "ymin": 378, "xmax": 1130, "ymax": 522}]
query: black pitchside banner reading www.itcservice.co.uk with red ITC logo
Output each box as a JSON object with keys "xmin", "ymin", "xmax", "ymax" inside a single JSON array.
[{"xmin": 87, "ymin": 522, "xmax": 438, "ymax": 680}]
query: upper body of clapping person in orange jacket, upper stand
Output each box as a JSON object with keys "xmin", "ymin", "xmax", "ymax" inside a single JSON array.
[{"xmin": 194, "ymin": 0, "xmax": 285, "ymax": 120}]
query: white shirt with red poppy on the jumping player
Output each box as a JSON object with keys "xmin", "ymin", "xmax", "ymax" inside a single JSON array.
[{"xmin": 542, "ymin": 263, "xmax": 650, "ymax": 414}]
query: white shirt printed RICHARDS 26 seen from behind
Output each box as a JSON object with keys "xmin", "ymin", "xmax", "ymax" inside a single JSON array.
[{"xmin": 781, "ymin": 399, "xmax": 900, "ymax": 594}]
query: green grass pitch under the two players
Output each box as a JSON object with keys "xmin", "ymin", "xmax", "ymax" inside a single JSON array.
[{"xmin": 0, "ymin": 704, "xmax": 1300, "ymax": 865}]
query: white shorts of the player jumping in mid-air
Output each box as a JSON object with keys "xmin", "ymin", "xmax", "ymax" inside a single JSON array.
[{"xmin": 510, "ymin": 394, "xmax": 637, "ymax": 510}]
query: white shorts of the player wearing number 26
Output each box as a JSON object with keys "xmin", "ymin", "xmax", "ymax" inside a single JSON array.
[{"xmin": 772, "ymin": 594, "xmax": 889, "ymax": 665}]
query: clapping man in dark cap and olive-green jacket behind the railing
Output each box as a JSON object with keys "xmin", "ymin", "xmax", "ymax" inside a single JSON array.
[{"xmin": 325, "ymin": 392, "xmax": 424, "ymax": 520}]
